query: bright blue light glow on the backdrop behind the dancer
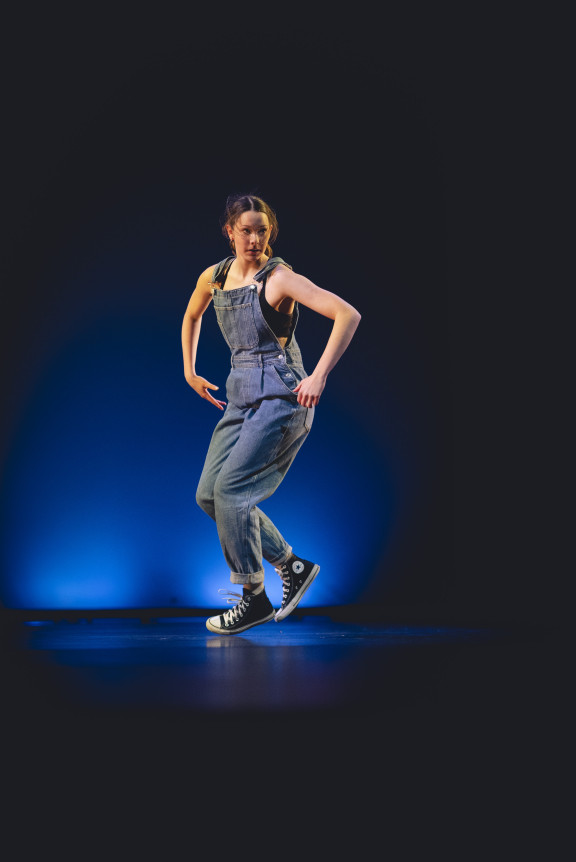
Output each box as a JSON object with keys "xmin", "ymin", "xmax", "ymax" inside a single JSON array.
[{"xmin": 2, "ymin": 308, "xmax": 394, "ymax": 609}]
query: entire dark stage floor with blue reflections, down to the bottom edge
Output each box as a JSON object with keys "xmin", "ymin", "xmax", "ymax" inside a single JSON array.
[{"xmin": 2, "ymin": 614, "xmax": 569, "ymax": 859}]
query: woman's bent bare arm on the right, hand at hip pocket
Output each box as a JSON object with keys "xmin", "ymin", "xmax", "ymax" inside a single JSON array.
[{"xmin": 266, "ymin": 266, "xmax": 361, "ymax": 407}]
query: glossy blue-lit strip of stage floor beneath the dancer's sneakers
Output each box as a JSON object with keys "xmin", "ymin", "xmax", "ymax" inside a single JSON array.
[{"xmin": 2, "ymin": 615, "xmax": 555, "ymax": 718}]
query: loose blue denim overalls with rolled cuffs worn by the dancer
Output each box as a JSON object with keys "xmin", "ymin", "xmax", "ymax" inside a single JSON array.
[{"xmin": 196, "ymin": 257, "xmax": 314, "ymax": 584}]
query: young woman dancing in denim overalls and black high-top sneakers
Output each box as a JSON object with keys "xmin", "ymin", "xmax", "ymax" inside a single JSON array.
[{"xmin": 182, "ymin": 195, "xmax": 360, "ymax": 635}]
